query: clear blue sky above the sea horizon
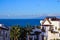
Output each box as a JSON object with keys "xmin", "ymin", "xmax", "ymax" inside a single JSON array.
[{"xmin": 0, "ymin": 0, "xmax": 60, "ymax": 19}]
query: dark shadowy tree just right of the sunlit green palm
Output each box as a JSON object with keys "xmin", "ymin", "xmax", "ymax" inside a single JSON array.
[{"xmin": 20, "ymin": 24, "xmax": 32, "ymax": 40}]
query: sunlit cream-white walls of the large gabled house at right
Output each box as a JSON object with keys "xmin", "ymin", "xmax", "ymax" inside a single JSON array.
[{"xmin": 40, "ymin": 20, "xmax": 60, "ymax": 40}]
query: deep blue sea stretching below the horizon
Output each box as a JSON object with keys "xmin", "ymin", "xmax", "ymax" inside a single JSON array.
[{"xmin": 0, "ymin": 19, "xmax": 41, "ymax": 26}]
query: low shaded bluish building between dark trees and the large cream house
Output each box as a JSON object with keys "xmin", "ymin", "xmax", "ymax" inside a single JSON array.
[{"xmin": 27, "ymin": 28, "xmax": 41, "ymax": 40}]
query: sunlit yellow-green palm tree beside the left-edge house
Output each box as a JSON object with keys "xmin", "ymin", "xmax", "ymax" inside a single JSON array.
[{"xmin": 10, "ymin": 25, "xmax": 20, "ymax": 40}]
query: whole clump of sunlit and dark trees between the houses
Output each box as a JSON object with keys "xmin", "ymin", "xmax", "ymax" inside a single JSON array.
[{"xmin": 10, "ymin": 24, "xmax": 32, "ymax": 40}]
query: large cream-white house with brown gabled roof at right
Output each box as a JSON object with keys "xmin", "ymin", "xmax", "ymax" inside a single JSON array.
[{"xmin": 40, "ymin": 17, "xmax": 60, "ymax": 40}]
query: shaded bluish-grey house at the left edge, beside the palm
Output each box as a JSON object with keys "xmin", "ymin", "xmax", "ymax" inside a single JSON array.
[{"xmin": 0, "ymin": 24, "xmax": 10, "ymax": 40}]
